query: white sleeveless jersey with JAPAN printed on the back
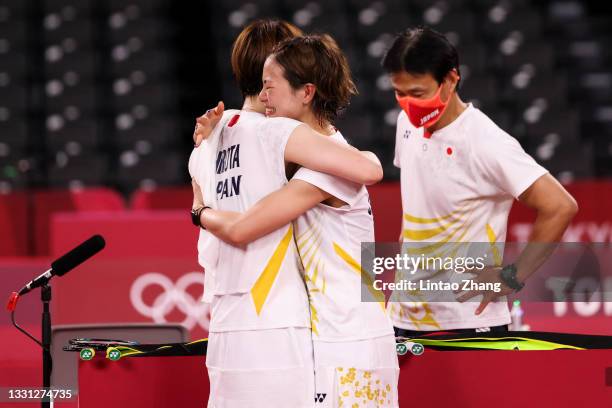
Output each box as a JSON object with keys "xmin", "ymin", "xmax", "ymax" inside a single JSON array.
[{"xmin": 210, "ymin": 111, "xmax": 310, "ymax": 332}]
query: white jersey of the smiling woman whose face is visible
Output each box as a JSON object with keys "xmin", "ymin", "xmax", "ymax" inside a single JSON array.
[{"xmin": 293, "ymin": 133, "xmax": 393, "ymax": 341}]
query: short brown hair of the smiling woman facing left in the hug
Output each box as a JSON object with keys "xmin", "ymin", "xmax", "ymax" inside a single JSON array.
[{"xmin": 272, "ymin": 34, "xmax": 357, "ymax": 123}]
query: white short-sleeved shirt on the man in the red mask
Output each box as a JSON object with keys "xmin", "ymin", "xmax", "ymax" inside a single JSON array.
[{"xmin": 389, "ymin": 104, "xmax": 547, "ymax": 330}]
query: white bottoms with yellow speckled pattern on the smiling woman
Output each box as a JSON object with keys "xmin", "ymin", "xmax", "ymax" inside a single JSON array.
[{"xmin": 313, "ymin": 335, "xmax": 399, "ymax": 408}]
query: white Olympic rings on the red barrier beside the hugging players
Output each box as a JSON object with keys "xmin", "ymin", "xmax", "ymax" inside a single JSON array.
[{"xmin": 130, "ymin": 272, "xmax": 210, "ymax": 330}]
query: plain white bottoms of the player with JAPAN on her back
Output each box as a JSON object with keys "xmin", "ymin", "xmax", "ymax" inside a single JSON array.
[{"xmin": 206, "ymin": 327, "xmax": 314, "ymax": 408}]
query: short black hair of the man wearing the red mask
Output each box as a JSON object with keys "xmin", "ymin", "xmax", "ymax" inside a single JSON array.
[{"xmin": 382, "ymin": 27, "xmax": 459, "ymax": 86}]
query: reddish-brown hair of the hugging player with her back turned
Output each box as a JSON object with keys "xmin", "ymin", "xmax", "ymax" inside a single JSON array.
[{"xmin": 231, "ymin": 19, "xmax": 302, "ymax": 98}]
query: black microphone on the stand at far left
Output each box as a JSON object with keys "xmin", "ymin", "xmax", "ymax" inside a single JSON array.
[{"xmin": 18, "ymin": 235, "xmax": 106, "ymax": 296}]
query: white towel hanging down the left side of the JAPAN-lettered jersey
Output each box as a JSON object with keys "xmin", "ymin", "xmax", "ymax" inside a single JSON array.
[{"xmin": 188, "ymin": 109, "xmax": 240, "ymax": 303}]
